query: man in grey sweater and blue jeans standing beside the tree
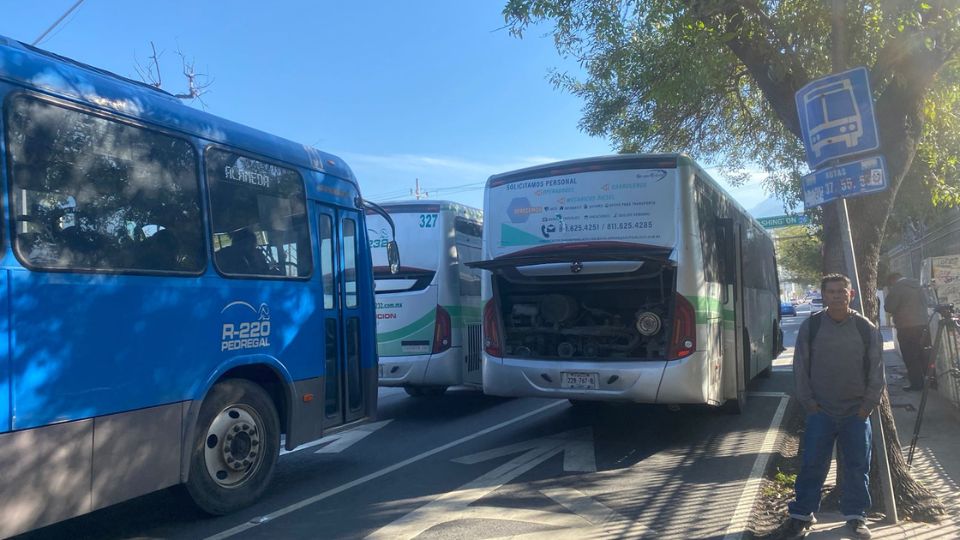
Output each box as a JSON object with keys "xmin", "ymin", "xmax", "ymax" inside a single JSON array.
[{"xmin": 786, "ymin": 274, "xmax": 884, "ymax": 538}]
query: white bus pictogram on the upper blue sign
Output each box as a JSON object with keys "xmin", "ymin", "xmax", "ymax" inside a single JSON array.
[{"xmin": 806, "ymin": 80, "xmax": 863, "ymax": 157}]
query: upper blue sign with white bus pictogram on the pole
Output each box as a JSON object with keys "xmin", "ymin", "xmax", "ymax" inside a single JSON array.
[{"xmin": 794, "ymin": 67, "xmax": 880, "ymax": 170}]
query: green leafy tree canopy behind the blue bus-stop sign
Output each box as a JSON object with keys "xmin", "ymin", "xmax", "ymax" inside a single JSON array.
[{"xmin": 504, "ymin": 0, "xmax": 960, "ymax": 311}]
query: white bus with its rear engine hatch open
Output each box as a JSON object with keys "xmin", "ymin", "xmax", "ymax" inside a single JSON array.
[{"xmin": 473, "ymin": 154, "xmax": 782, "ymax": 411}]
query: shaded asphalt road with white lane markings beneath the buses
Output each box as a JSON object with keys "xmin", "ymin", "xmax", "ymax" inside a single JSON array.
[{"xmin": 16, "ymin": 312, "xmax": 809, "ymax": 539}]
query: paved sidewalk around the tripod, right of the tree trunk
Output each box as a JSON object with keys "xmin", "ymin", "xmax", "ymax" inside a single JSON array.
[{"xmin": 807, "ymin": 328, "xmax": 960, "ymax": 540}]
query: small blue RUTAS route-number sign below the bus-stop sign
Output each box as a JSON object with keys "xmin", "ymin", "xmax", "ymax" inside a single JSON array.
[{"xmin": 803, "ymin": 156, "xmax": 887, "ymax": 210}]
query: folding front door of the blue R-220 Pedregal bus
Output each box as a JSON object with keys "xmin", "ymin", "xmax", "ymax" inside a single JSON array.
[{"xmin": 317, "ymin": 205, "xmax": 366, "ymax": 428}]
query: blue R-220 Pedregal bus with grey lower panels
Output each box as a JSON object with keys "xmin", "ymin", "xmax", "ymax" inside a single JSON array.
[{"xmin": 0, "ymin": 37, "xmax": 399, "ymax": 537}]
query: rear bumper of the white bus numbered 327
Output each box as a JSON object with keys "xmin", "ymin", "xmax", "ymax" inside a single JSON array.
[{"xmin": 380, "ymin": 347, "xmax": 462, "ymax": 386}]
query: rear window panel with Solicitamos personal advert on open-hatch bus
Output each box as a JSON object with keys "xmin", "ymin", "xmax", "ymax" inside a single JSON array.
[{"xmin": 486, "ymin": 165, "xmax": 677, "ymax": 258}]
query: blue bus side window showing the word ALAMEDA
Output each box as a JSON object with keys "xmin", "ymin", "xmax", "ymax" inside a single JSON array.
[{"xmin": 206, "ymin": 148, "xmax": 313, "ymax": 278}]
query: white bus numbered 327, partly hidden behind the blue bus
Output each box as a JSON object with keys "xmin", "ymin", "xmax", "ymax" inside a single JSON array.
[{"xmin": 367, "ymin": 201, "xmax": 483, "ymax": 396}]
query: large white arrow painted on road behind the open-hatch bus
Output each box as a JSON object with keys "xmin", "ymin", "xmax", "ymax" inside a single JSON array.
[{"xmin": 367, "ymin": 428, "xmax": 616, "ymax": 540}]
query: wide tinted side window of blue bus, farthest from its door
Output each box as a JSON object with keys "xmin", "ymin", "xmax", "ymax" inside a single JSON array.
[{"xmin": 6, "ymin": 96, "xmax": 206, "ymax": 274}]
